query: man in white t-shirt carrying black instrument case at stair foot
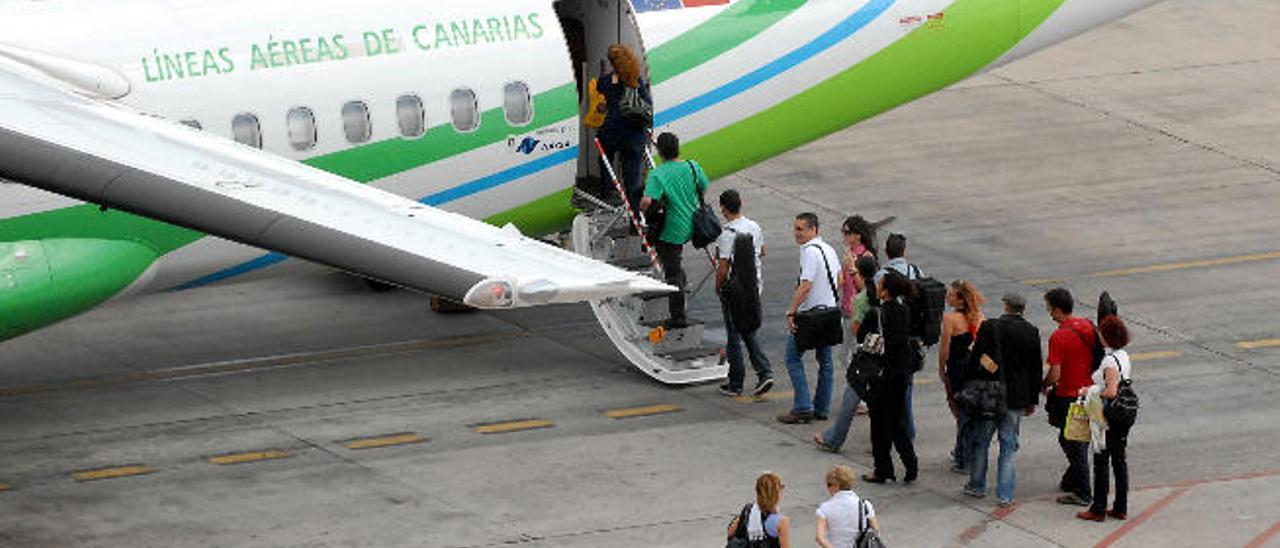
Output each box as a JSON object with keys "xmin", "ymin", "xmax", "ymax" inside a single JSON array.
[{"xmin": 716, "ymin": 188, "xmax": 773, "ymax": 396}]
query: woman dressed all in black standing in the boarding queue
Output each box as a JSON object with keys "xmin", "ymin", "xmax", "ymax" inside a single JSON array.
[{"xmin": 863, "ymin": 271, "xmax": 919, "ymax": 483}]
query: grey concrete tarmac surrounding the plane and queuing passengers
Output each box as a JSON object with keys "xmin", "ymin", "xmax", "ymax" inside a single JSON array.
[{"xmin": 0, "ymin": 0, "xmax": 1280, "ymax": 547}]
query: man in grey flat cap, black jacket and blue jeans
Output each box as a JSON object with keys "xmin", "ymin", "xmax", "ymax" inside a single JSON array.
[{"xmin": 964, "ymin": 293, "xmax": 1044, "ymax": 507}]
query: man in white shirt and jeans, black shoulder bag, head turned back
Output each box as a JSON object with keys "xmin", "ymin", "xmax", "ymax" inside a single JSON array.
[{"xmin": 778, "ymin": 213, "xmax": 844, "ymax": 424}]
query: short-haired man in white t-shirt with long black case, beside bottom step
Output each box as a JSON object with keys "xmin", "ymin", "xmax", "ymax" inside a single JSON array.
[{"xmin": 716, "ymin": 188, "xmax": 773, "ymax": 396}]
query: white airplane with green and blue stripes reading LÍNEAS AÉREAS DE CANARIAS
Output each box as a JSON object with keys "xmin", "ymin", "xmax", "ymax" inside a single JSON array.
[{"xmin": 0, "ymin": 0, "xmax": 1158, "ymax": 383}]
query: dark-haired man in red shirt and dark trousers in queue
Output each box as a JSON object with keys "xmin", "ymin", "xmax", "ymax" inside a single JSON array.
[{"xmin": 1044, "ymin": 288, "xmax": 1097, "ymax": 506}]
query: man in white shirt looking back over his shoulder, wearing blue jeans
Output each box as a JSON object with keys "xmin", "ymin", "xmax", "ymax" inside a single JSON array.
[{"xmin": 778, "ymin": 213, "xmax": 840, "ymax": 424}]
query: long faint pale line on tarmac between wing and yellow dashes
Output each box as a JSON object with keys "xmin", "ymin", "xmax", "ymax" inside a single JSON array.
[{"xmin": 0, "ymin": 332, "xmax": 527, "ymax": 398}]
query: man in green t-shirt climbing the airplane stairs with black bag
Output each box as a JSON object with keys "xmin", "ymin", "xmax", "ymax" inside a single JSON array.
[{"xmin": 640, "ymin": 133, "xmax": 707, "ymax": 328}]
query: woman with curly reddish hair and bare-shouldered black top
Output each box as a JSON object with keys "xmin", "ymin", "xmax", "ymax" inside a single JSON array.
[{"xmin": 938, "ymin": 279, "xmax": 987, "ymax": 474}]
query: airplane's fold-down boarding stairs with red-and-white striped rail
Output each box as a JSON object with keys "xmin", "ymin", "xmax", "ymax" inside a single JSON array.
[{"xmin": 572, "ymin": 141, "xmax": 728, "ymax": 384}]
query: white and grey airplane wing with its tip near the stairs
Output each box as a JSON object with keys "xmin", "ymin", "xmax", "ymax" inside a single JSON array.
[{"xmin": 0, "ymin": 56, "xmax": 673, "ymax": 309}]
